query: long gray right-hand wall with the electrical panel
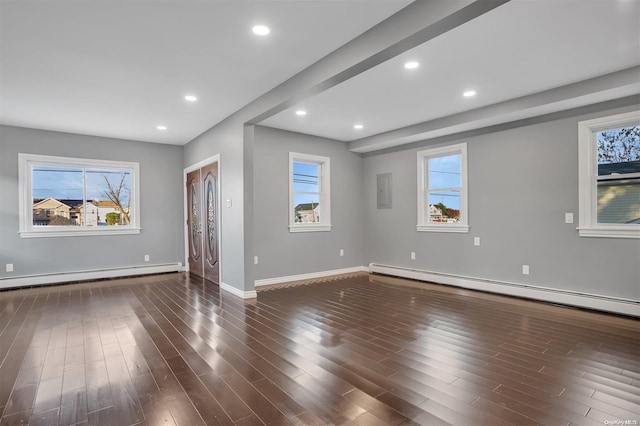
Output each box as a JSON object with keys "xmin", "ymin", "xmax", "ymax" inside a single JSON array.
[{"xmin": 363, "ymin": 108, "xmax": 640, "ymax": 300}]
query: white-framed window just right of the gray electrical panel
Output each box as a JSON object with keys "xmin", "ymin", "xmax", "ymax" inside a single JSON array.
[{"xmin": 417, "ymin": 144, "xmax": 469, "ymax": 232}]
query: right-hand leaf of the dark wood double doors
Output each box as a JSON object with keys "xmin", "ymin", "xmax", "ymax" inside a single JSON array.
[{"xmin": 200, "ymin": 163, "xmax": 220, "ymax": 283}]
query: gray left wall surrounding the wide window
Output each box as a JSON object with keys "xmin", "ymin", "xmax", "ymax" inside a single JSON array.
[{"xmin": 0, "ymin": 126, "xmax": 184, "ymax": 278}]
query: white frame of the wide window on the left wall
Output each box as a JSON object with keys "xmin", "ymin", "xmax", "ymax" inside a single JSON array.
[{"xmin": 18, "ymin": 153, "xmax": 141, "ymax": 238}]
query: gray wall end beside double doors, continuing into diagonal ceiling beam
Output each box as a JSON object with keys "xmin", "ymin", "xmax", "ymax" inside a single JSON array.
[{"xmin": 184, "ymin": 0, "xmax": 470, "ymax": 292}]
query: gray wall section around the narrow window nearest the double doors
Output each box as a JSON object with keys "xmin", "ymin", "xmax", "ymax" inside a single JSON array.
[{"xmin": 253, "ymin": 126, "xmax": 364, "ymax": 279}]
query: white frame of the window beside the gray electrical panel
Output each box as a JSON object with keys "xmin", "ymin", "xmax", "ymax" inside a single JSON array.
[{"xmin": 416, "ymin": 143, "xmax": 469, "ymax": 233}]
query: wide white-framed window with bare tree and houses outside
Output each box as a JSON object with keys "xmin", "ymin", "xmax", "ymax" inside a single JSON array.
[{"xmin": 18, "ymin": 154, "xmax": 140, "ymax": 238}]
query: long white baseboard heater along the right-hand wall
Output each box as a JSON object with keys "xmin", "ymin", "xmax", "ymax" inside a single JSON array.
[{"xmin": 369, "ymin": 263, "xmax": 640, "ymax": 317}]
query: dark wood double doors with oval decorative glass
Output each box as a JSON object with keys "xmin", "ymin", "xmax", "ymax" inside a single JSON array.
[{"xmin": 185, "ymin": 159, "xmax": 220, "ymax": 284}]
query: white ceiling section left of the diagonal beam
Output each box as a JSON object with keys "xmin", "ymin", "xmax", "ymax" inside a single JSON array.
[{"xmin": 0, "ymin": 0, "xmax": 410, "ymax": 144}]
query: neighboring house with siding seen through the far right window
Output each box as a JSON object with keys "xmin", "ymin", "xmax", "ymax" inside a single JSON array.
[{"xmin": 598, "ymin": 161, "xmax": 640, "ymax": 224}]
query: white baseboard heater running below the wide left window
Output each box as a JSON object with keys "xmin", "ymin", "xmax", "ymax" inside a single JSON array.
[{"xmin": 0, "ymin": 262, "xmax": 184, "ymax": 289}]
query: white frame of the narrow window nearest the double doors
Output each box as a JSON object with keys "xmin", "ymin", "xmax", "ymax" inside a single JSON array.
[{"xmin": 289, "ymin": 152, "xmax": 331, "ymax": 232}]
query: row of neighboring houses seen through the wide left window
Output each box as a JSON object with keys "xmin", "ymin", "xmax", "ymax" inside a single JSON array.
[{"xmin": 33, "ymin": 198, "xmax": 122, "ymax": 226}]
